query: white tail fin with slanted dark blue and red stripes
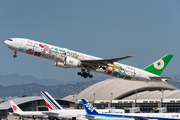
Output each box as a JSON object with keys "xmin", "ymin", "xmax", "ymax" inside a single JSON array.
[{"xmin": 41, "ymin": 91, "xmax": 63, "ymax": 111}]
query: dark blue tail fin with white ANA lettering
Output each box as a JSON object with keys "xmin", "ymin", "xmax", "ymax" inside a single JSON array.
[{"xmin": 81, "ymin": 99, "xmax": 99, "ymax": 115}]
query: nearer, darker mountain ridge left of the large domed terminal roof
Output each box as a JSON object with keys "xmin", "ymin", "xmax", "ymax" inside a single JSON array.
[{"xmin": 0, "ymin": 80, "xmax": 102, "ymax": 98}]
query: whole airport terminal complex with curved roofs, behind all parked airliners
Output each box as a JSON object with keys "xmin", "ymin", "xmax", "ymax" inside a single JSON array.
[{"xmin": 0, "ymin": 78, "xmax": 180, "ymax": 119}]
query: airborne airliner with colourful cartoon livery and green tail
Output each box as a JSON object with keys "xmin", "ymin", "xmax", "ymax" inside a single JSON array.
[{"xmin": 4, "ymin": 38, "xmax": 173, "ymax": 81}]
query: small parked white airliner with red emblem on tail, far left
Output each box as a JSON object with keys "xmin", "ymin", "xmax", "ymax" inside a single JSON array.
[{"xmin": 10, "ymin": 100, "xmax": 48, "ymax": 118}]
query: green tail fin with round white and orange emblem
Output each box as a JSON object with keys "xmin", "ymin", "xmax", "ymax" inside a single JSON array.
[{"xmin": 144, "ymin": 54, "xmax": 173, "ymax": 76}]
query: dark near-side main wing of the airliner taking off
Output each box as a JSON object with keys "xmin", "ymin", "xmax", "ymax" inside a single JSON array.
[{"xmin": 81, "ymin": 56, "xmax": 133, "ymax": 69}]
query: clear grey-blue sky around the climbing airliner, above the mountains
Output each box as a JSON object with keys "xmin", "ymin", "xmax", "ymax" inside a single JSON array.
[{"xmin": 0, "ymin": 0, "xmax": 180, "ymax": 81}]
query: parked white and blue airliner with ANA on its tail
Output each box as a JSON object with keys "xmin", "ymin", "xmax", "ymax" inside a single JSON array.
[{"xmin": 81, "ymin": 99, "xmax": 180, "ymax": 120}]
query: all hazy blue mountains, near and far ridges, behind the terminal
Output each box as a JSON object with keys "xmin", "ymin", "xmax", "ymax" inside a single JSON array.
[{"xmin": 0, "ymin": 74, "xmax": 180, "ymax": 98}]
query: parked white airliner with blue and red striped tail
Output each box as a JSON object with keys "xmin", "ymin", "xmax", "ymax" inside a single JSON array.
[{"xmin": 41, "ymin": 92, "xmax": 124, "ymax": 120}]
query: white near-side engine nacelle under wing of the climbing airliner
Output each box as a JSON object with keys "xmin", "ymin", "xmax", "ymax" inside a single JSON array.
[{"xmin": 64, "ymin": 56, "xmax": 81, "ymax": 68}]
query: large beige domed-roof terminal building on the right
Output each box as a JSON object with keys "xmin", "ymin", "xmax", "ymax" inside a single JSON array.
[{"xmin": 62, "ymin": 78, "xmax": 180, "ymax": 112}]
